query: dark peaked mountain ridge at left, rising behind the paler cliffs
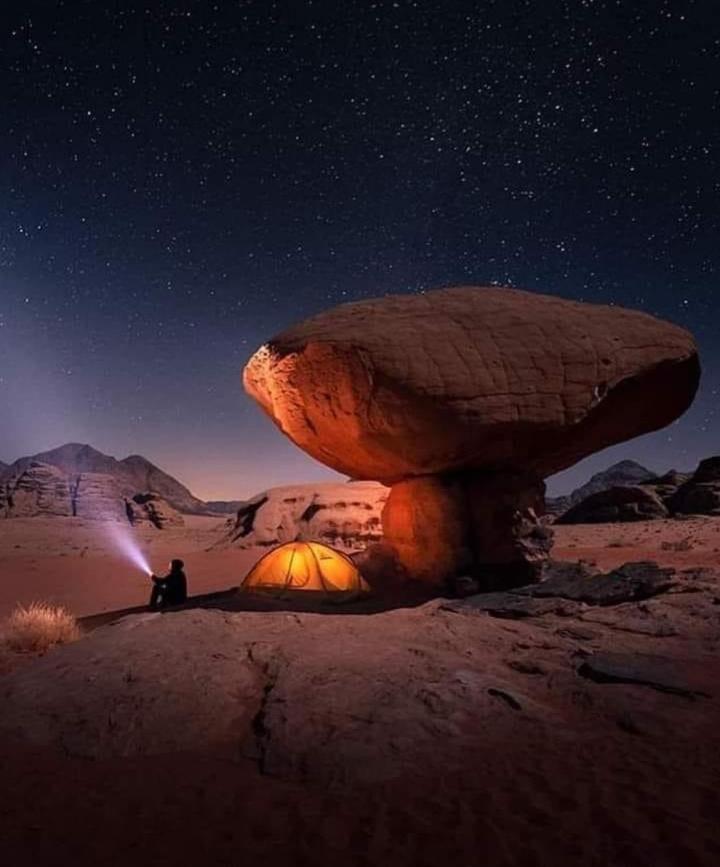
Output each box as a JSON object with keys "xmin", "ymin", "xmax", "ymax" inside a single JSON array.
[{"xmin": 0, "ymin": 443, "xmax": 208, "ymax": 514}]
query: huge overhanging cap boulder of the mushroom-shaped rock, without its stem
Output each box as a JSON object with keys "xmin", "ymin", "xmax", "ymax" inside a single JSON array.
[{"xmin": 244, "ymin": 287, "xmax": 699, "ymax": 482}]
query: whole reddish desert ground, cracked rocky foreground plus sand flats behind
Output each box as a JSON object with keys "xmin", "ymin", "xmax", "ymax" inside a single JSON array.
[{"xmin": 0, "ymin": 518, "xmax": 720, "ymax": 867}]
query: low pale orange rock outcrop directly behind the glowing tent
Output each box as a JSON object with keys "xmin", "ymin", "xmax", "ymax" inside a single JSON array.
[{"xmin": 225, "ymin": 482, "xmax": 389, "ymax": 551}]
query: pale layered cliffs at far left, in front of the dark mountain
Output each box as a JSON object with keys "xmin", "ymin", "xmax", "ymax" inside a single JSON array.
[{"xmin": 0, "ymin": 460, "xmax": 183, "ymax": 528}]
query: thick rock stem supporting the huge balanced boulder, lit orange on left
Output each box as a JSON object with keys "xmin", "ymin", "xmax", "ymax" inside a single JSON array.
[{"xmin": 382, "ymin": 472, "xmax": 552, "ymax": 589}]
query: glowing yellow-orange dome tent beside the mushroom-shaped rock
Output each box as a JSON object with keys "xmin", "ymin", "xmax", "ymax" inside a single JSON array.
[{"xmin": 241, "ymin": 542, "xmax": 369, "ymax": 602}]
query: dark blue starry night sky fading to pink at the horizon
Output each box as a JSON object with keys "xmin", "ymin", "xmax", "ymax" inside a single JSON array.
[{"xmin": 0, "ymin": 0, "xmax": 720, "ymax": 498}]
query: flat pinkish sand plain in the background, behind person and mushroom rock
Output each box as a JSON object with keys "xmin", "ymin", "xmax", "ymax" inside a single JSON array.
[{"xmin": 0, "ymin": 516, "xmax": 720, "ymax": 618}]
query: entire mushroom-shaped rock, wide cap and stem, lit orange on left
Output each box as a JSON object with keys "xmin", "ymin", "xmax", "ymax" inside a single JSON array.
[{"xmin": 243, "ymin": 287, "xmax": 700, "ymax": 585}]
